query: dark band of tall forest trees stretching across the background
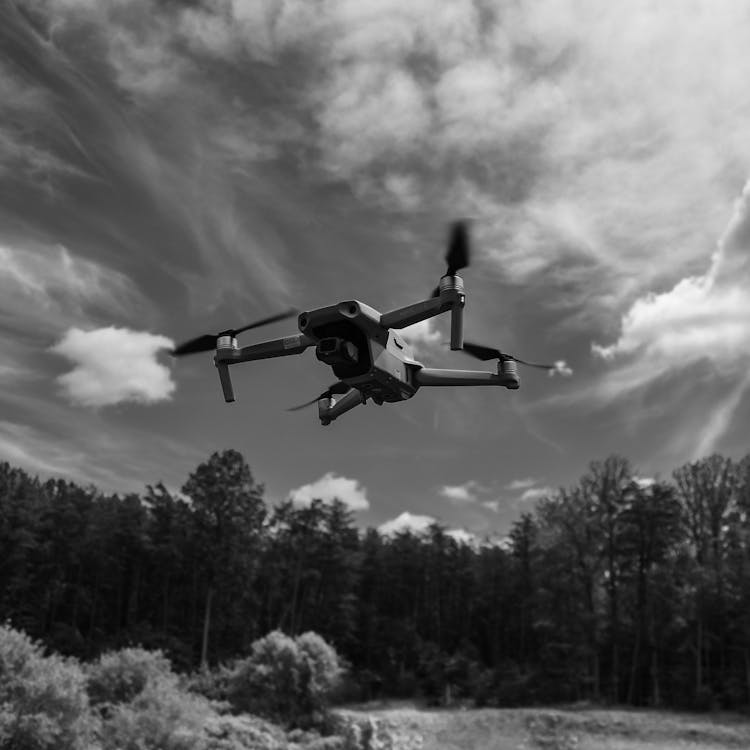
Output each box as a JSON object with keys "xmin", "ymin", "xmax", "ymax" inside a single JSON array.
[{"xmin": 0, "ymin": 451, "xmax": 750, "ymax": 708}]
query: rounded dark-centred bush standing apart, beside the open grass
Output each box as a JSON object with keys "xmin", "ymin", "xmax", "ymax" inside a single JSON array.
[{"xmin": 229, "ymin": 630, "xmax": 343, "ymax": 726}]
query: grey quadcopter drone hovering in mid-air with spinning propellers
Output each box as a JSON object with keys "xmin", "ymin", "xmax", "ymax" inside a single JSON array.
[{"xmin": 172, "ymin": 221, "xmax": 555, "ymax": 425}]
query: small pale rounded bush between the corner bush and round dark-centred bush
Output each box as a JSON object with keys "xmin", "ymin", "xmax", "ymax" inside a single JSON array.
[{"xmin": 88, "ymin": 648, "xmax": 177, "ymax": 707}]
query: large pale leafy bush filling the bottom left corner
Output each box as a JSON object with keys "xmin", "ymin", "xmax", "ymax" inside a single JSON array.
[{"xmin": 0, "ymin": 626, "xmax": 95, "ymax": 750}]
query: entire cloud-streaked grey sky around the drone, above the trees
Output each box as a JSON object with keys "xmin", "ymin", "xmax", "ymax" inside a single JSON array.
[{"xmin": 0, "ymin": 0, "xmax": 750, "ymax": 534}]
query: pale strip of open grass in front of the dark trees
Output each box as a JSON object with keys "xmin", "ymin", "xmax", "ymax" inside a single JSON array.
[{"xmin": 340, "ymin": 704, "xmax": 750, "ymax": 750}]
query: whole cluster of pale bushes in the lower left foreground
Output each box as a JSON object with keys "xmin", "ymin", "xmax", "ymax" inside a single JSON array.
[{"xmin": 0, "ymin": 626, "xmax": 350, "ymax": 750}]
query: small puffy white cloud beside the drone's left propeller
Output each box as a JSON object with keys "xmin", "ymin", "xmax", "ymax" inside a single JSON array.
[{"xmin": 51, "ymin": 326, "xmax": 175, "ymax": 407}]
